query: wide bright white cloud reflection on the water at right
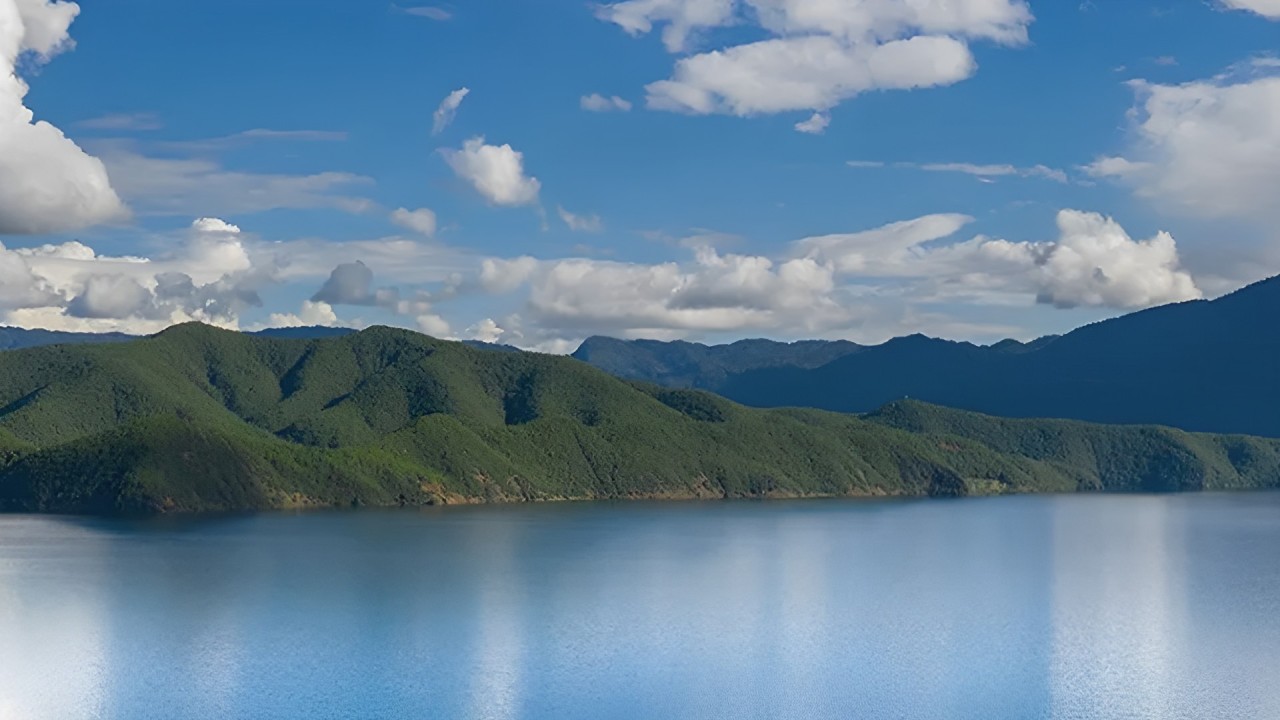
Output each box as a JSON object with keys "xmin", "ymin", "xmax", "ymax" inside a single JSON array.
[{"xmin": 1051, "ymin": 497, "xmax": 1198, "ymax": 717}]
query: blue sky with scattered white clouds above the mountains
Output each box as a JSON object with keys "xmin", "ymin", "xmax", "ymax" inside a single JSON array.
[{"xmin": 0, "ymin": 0, "xmax": 1280, "ymax": 352}]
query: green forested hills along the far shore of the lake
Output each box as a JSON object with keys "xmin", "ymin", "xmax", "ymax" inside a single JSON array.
[{"xmin": 0, "ymin": 324, "xmax": 1280, "ymax": 514}]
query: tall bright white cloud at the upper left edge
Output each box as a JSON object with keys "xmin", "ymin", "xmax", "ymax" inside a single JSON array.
[{"xmin": 0, "ymin": 0, "xmax": 128, "ymax": 234}]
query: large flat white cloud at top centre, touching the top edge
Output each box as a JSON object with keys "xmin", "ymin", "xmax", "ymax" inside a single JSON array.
[{"xmin": 598, "ymin": 0, "xmax": 1033, "ymax": 117}]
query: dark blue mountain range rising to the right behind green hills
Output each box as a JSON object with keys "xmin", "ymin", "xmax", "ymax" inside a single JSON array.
[{"xmin": 579, "ymin": 278, "xmax": 1280, "ymax": 437}]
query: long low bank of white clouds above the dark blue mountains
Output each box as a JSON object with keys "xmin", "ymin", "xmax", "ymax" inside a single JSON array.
[{"xmin": 478, "ymin": 210, "xmax": 1201, "ymax": 345}]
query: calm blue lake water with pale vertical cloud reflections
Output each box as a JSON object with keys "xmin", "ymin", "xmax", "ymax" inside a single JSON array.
[{"xmin": 0, "ymin": 495, "xmax": 1280, "ymax": 720}]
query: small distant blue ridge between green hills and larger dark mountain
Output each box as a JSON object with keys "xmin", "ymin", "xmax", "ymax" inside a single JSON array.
[{"xmin": 573, "ymin": 337, "xmax": 863, "ymax": 389}]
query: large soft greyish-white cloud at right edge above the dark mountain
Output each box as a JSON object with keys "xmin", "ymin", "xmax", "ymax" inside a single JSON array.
[{"xmin": 1085, "ymin": 70, "xmax": 1280, "ymax": 227}]
